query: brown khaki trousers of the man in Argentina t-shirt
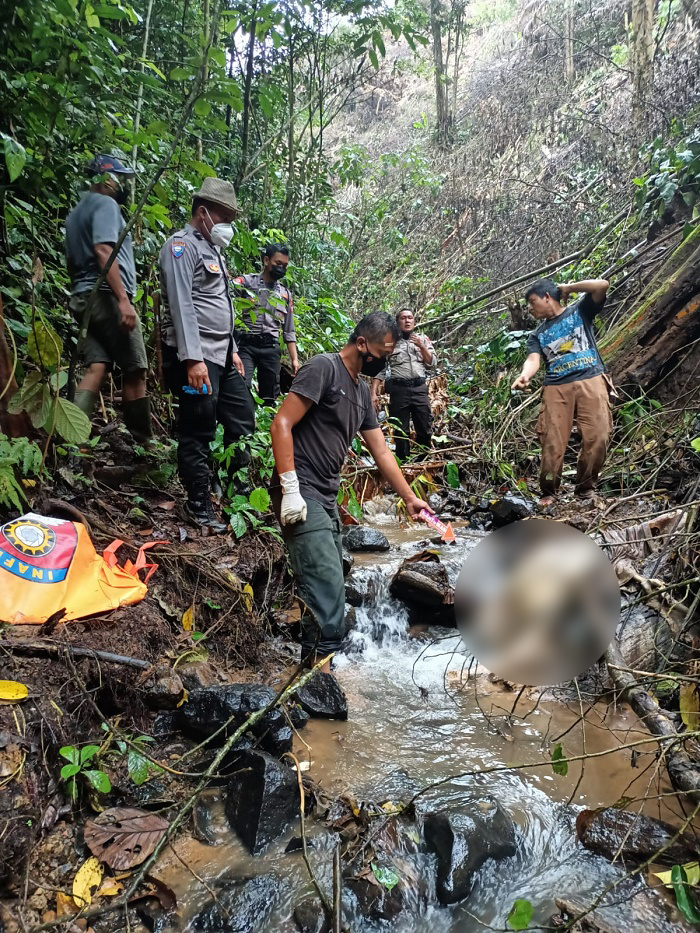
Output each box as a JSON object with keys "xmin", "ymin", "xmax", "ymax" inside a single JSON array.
[{"xmin": 535, "ymin": 376, "xmax": 612, "ymax": 496}]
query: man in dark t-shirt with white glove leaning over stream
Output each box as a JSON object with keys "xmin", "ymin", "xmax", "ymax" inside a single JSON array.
[{"xmin": 270, "ymin": 311, "xmax": 432, "ymax": 664}]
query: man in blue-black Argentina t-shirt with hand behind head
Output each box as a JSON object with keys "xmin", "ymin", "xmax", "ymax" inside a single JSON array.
[{"xmin": 511, "ymin": 279, "xmax": 612, "ymax": 506}]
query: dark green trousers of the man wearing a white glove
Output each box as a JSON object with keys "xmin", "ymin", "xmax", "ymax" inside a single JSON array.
[{"xmin": 278, "ymin": 499, "xmax": 345, "ymax": 657}]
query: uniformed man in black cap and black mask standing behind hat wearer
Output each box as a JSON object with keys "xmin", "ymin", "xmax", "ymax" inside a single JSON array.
[{"xmin": 234, "ymin": 243, "xmax": 299, "ymax": 405}]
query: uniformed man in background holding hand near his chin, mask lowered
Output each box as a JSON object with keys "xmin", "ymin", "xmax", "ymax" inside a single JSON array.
[{"xmin": 372, "ymin": 311, "xmax": 436, "ymax": 460}]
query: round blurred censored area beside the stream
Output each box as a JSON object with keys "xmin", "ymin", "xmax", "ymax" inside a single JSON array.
[{"xmin": 455, "ymin": 519, "xmax": 620, "ymax": 686}]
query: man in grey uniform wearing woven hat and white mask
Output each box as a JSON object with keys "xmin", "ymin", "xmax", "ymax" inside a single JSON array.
[{"xmin": 158, "ymin": 178, "xmax": 255, "ymax": 534}]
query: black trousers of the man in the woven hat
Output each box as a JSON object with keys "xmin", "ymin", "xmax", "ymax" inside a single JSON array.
[{"xmin": 163, "ymin": 345, "xmax": 255, "ymax": 499}]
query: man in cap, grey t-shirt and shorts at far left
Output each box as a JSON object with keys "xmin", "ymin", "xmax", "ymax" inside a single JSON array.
[{"xmin": 65, "ymin": 155, "xmax": 152, "ymax": 443}]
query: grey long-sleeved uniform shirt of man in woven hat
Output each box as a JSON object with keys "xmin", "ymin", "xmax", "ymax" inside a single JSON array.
[{"xmin": 158, "ymin": 224, "xmax": 238, "ymax": 366}]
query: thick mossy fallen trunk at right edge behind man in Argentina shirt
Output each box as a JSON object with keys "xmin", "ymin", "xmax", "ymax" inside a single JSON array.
[{"xmin": 599, "ymin": 227, "xmax": 700, "ymax": 390}]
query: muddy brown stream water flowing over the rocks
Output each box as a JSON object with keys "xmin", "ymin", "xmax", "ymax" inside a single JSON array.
[{"xmin": 159, "ymin": 528, "xmax": 674, "ymax": 933}]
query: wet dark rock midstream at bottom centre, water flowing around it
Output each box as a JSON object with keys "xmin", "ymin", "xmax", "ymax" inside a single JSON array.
[{"xmin": 424, "ymin": 796, "xmax": 516, "ymax": 904}]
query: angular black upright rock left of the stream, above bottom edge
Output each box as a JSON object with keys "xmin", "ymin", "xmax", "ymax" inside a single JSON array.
[{"xmin": 226, "ymin": 749, "xmax": 299, "ymax": 855}]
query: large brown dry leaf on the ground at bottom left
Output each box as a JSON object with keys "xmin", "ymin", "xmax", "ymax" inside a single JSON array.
[{"xmin": 85, "ymin": 807, "xmax": 169, "ymax": 871}]
